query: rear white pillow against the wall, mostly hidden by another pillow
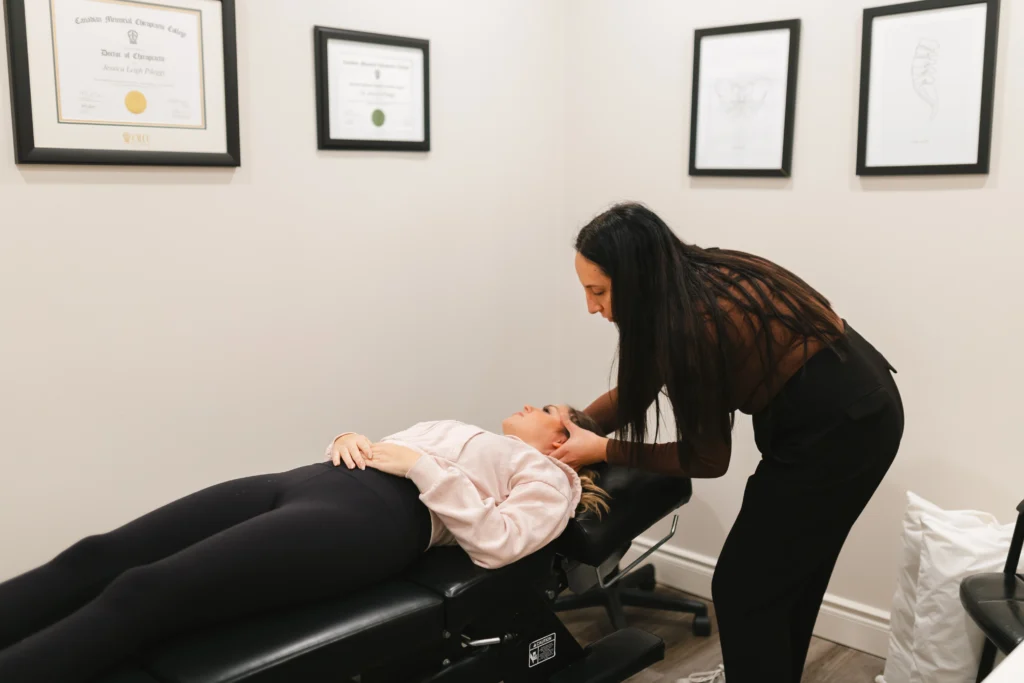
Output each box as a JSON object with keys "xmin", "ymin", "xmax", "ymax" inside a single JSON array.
[{"xmin": 881, "ymin": 492, "xmax": 998, "ymax": 683}]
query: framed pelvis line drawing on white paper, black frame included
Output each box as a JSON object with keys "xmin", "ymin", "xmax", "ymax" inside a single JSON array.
[{"xmin": 690, "ymin": 19, "xmax": 800, "ymax": 177}]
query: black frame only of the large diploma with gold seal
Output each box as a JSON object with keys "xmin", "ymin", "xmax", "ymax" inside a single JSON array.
[{"xmin": 4, "ymin": 0, "xmax": 242, "ymax": 167}]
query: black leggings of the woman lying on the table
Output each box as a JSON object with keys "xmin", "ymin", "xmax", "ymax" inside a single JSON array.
[{"xmin": 0, "ymin": 463, "xmax": 430, "ymax": 683}]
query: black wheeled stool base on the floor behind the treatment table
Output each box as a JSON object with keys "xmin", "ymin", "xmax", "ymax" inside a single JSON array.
[{"xmin": 555, "ymin": 564, "xmax": 711, "ymax": 637}]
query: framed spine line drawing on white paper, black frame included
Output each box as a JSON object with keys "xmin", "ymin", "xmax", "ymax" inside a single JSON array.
[{"xmin": 857, "ymin": 0, "xmax": 999, "ymax": 175}]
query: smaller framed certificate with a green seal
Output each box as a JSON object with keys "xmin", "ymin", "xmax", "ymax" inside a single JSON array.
[{"xmin": 313, "ymin": 27, "xmax": 430, "ymax": 152}]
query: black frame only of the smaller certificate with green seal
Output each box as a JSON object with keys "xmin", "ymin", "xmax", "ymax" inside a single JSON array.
[{"xmin": 313, "ymin": 26, "xmax": 430, "ymax": 152}]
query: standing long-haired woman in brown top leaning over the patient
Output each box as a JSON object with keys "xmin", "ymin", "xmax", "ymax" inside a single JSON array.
[{"xmin": 553, "ymin": 204, "xmax": 903, "ymax": 683}]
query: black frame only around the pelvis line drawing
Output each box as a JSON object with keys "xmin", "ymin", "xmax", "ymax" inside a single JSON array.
[{"xmin": 689, "ymin": 18, "xmax": 801, "ymax": 178}]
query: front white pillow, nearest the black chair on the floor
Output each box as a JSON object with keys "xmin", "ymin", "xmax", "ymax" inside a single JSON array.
[{"xmin": 910, "ymin": 513, "xmax": 1014, "ymax": 683}]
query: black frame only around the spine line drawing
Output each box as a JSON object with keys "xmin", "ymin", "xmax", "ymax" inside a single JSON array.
[{"xmin": 857, "ymin": 0, "xmax": 999, "ymax": 176}]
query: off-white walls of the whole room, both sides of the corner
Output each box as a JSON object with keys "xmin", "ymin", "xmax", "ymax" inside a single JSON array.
[{"xmin": 0, "ymin": 0, "xmax": 1024, "ymax": 663}]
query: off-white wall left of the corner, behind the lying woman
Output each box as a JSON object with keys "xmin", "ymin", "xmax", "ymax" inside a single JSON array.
[{"xmin": 0, "ymin": 0, "xmax": 564, "ymax": 580}]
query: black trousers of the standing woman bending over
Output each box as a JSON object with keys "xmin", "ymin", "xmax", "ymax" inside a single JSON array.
[{"xmin": 712, "ymin": 326, "xmax": 903, "ymax": 683}]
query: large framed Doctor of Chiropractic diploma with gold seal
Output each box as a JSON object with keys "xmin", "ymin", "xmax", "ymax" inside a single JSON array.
[{"xmin": 4, "ymin": 0, "xmax": 241, "ymax": 166}]
